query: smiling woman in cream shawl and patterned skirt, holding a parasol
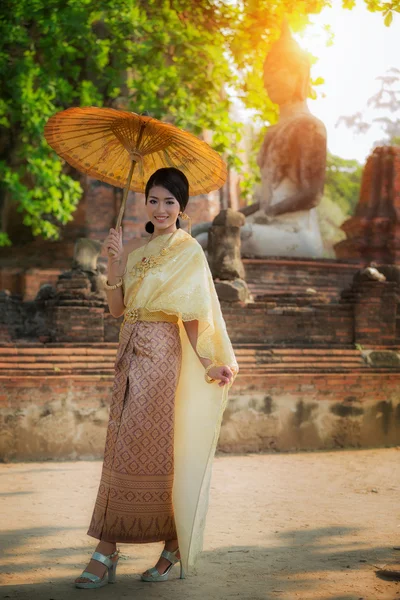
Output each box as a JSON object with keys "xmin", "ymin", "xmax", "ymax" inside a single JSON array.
[{"xmin": 75, "ymin": 168, "xmax": 238, "ymax": 588}]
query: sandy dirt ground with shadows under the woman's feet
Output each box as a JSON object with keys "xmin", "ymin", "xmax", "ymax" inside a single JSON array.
[{"xmin": 0, "ymin": 448, "xmax": 400, "ymax": 600}]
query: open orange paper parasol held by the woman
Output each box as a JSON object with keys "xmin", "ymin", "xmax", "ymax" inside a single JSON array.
[{"xmin": 44, "ymin": 107, "xmax": 226, "ymax": 229}]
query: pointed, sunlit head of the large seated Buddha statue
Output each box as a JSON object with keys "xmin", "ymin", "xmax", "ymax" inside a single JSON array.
[{"xmin": 264, "ymin": 21, "xmax": 310, "ymax": 105}]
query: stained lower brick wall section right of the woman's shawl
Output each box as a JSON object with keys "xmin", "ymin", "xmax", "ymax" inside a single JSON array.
[{"xmin": 219, "ymin": 372, "xmax": 400, "ymax": 452}]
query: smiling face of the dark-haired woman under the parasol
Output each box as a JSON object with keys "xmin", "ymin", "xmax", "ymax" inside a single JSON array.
[{"xmin": 146, "ymin": 185, "xmax": 181, "ymax": 234}]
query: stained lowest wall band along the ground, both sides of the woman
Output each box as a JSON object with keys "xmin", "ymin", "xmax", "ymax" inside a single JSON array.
[{"xmin": 0, "ymin": 366, "xmax": 400, "ymax": 460}]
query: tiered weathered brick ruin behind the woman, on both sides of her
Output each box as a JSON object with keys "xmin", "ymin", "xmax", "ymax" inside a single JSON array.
[{"xmin": 0, "ymin": 151, "xmax": 400, "ymax": 460}]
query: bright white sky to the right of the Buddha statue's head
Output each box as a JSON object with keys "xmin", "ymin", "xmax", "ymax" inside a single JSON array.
[{"xmin": 295, "ymin": 0, "xmax": 400, "ymax": 163}]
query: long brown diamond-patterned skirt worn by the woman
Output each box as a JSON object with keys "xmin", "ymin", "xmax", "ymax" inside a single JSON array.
[{"xmin": 87, "ymin": 321, "xmax": 182, "ymax": 544}]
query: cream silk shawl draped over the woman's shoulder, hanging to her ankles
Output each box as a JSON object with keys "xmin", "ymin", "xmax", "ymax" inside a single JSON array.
[{"xmin": 123, "ymin": 229, "xmax": 238, "ymax": 573}]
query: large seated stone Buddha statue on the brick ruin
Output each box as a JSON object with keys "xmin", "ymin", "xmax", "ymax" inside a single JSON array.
[{"xmin": 241, "ymin": 23, "xmax": 326, "ymax": 257}]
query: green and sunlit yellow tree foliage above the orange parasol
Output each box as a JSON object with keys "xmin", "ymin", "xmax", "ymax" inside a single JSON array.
[{"xmin": 0, "ymin": 0, "xmax": 400, "ymax": 245}]
